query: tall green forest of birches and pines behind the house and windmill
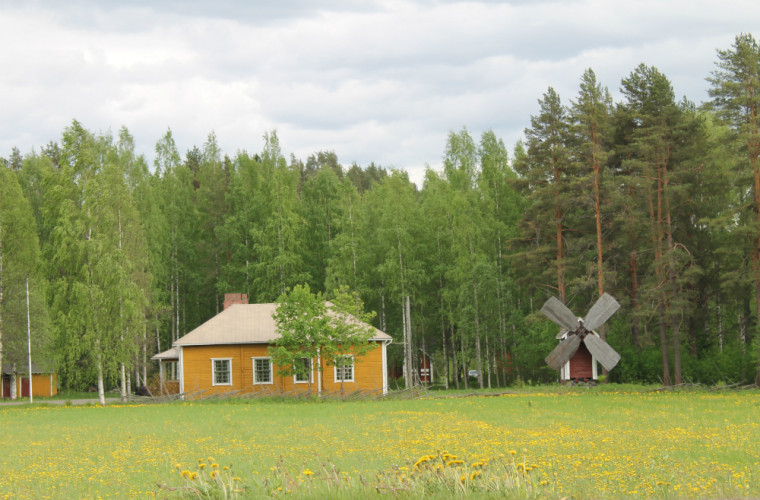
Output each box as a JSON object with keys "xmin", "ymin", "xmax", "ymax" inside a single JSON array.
[{"xmin": 0, "ymin": 34, "xmax": 760, "ymax": 391}]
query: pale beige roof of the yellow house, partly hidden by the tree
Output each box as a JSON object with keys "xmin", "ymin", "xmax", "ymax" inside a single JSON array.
[{"xmin": 173, "ymin": 303, "xmax": 391, "ymax": 347}]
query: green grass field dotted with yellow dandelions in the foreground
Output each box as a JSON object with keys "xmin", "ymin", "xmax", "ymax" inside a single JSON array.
[{"xmin": 0, "ymin": 386, "xmax": 760, "ymax": 498}]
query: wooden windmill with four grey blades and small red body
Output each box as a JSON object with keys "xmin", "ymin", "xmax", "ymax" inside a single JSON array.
[{"xmin": 541, "ymin": 293, "xmax": 620, "ymax": 381}]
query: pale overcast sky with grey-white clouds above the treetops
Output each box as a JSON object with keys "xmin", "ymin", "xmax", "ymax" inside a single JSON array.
[{"xmin": 0, "ymin": 0, "xmax": 760, "ymax": 184}]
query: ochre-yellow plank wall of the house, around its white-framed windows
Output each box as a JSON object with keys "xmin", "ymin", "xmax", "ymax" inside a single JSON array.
[{"xmin": 182, "ymin": 342, "xmax": 383, "ymax": 396}]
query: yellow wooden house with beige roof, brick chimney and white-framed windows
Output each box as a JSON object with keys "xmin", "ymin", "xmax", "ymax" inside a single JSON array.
[{"xmin": 154, "ymin": 294, "xmax": 392, "ymax": 396}]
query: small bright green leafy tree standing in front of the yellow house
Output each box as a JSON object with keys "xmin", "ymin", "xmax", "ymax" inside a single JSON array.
[{"xmin": 269, "ymin": 284, "xmax": 375, "ymax": 393}]
